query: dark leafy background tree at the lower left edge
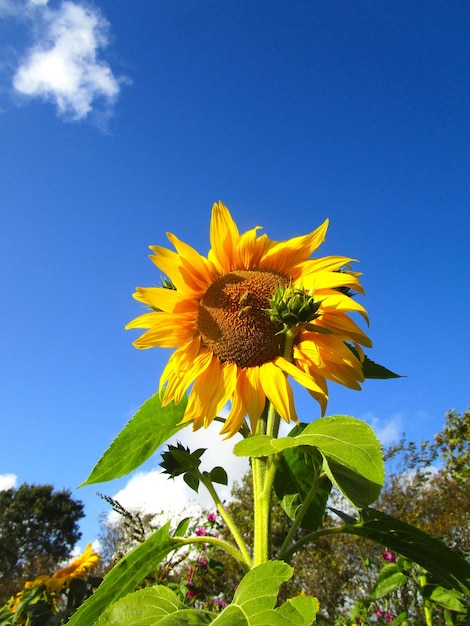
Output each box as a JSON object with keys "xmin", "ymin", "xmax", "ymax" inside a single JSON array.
[{"xmin": 0, "ymin": 483, "xmax": 84, "ymax": 603}]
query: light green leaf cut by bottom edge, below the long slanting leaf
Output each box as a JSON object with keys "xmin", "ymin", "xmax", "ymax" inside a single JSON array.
[{"xmin": 95, "ymin": 585, "xmax": 211, "ymax": 626}]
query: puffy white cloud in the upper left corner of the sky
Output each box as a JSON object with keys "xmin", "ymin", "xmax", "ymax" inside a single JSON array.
[{"xmin": 13, "ymin": 0, "xmax": 128, "ymax": 120}]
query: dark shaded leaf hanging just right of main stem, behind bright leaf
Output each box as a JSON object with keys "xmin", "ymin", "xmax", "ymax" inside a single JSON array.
[{"xmin": 274, "ymin": 425, "xmax": 331, "ymax": 531}]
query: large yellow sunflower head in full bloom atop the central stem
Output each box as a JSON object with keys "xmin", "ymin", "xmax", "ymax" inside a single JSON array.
[{"xmin": 126, "ymin": 202, "xmax": 371, "ymax": 436}]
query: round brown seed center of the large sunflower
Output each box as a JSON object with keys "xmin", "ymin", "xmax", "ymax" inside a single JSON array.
[{"xmin": 197, "ymin": 270, "xmax": 289, "ymax": 367}]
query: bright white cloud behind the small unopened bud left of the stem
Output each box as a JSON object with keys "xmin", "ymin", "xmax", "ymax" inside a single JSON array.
[{"xmin": 110, "ymin": 416, "xmax": 249, "ymax": 521}]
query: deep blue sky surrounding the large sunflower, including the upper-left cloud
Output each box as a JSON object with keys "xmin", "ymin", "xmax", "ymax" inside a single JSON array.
[{"xmin": 0, "ymin": 0, "xmax": 470, "ymax": 544}]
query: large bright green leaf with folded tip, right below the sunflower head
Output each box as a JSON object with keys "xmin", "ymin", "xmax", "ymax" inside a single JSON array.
[{"xmin": 234, "ymin": 415, "xmax": 384, "ymax": 508}]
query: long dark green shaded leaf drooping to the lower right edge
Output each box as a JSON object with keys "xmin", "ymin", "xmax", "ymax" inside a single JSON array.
[{"xmin": 324, "ymin": 509, "xmax": 470, "ymax": 593}]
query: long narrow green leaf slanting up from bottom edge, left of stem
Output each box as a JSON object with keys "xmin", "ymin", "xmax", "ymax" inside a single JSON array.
[{"xmin": 67, "ymin": 522, "xmax": 178, "ymax": 626}]
